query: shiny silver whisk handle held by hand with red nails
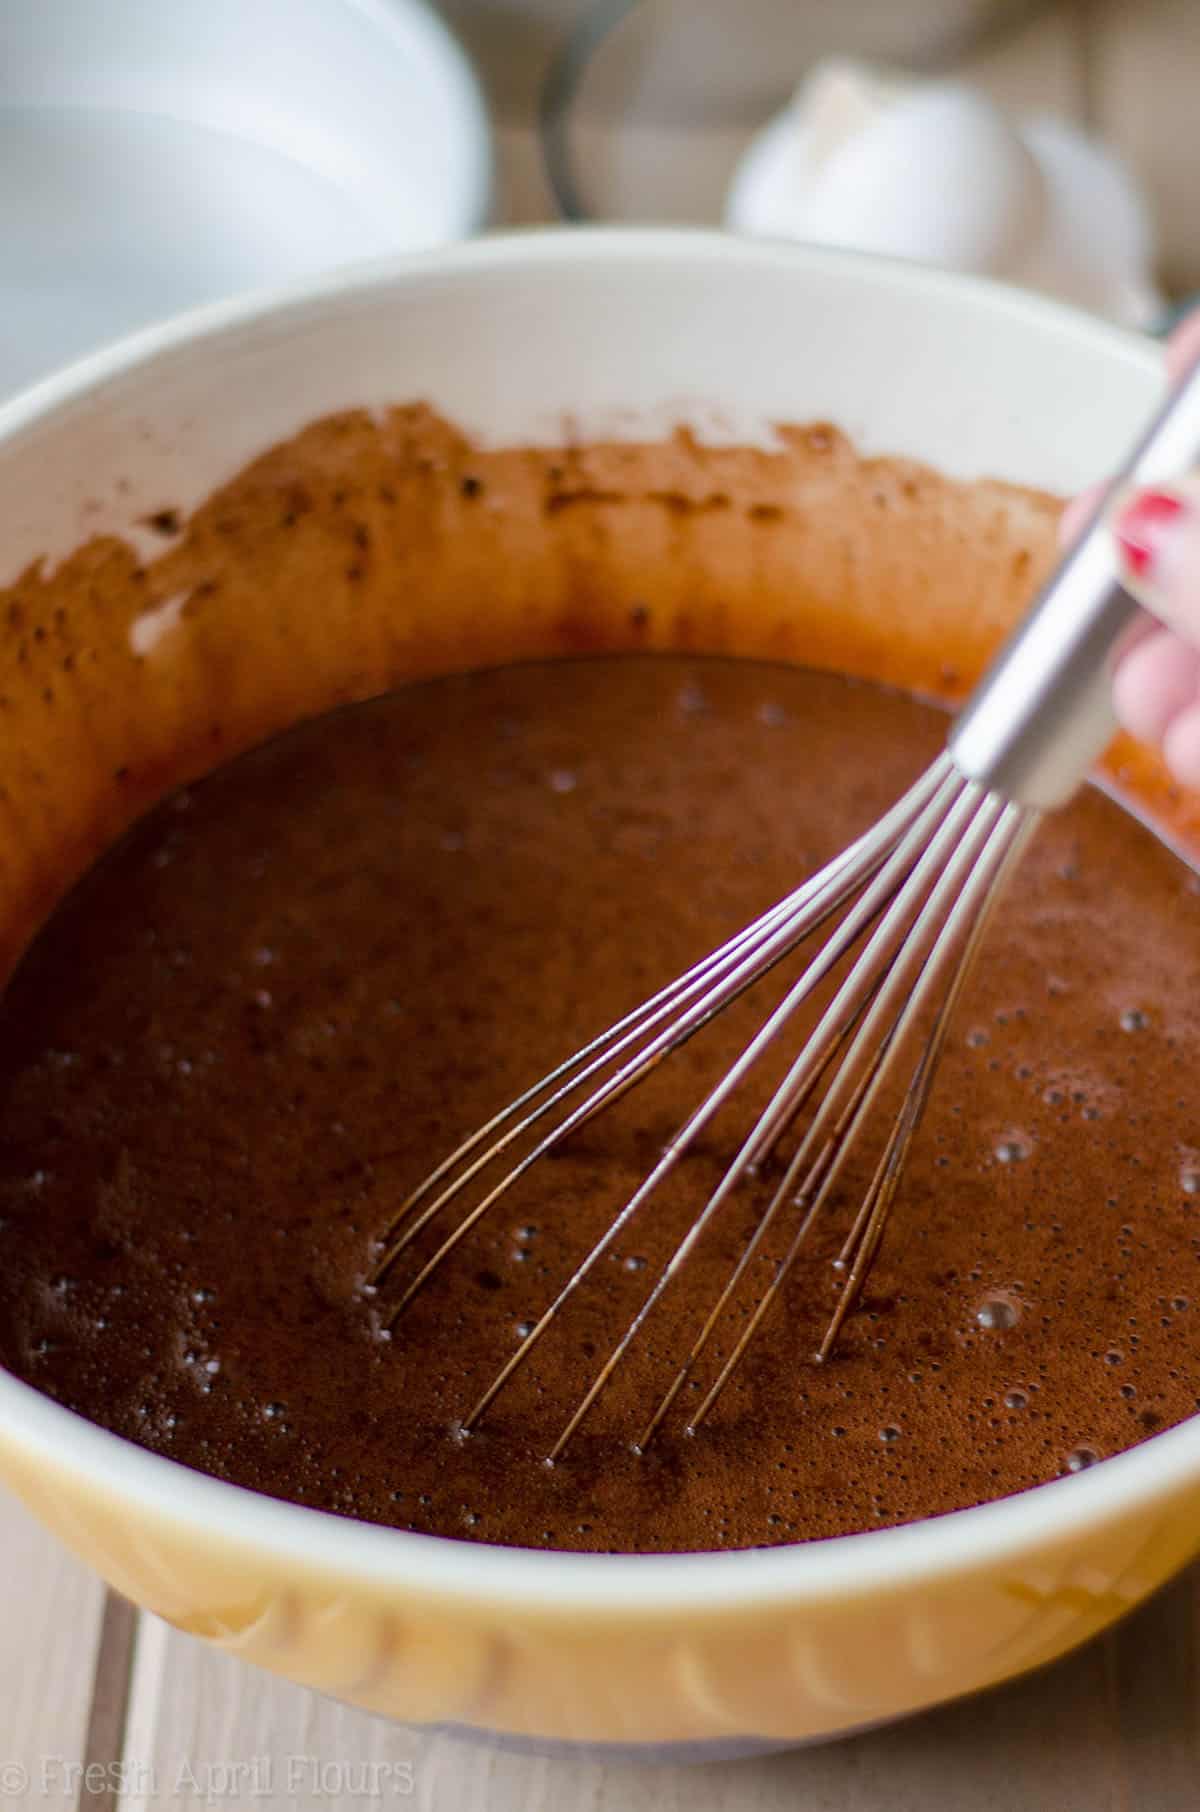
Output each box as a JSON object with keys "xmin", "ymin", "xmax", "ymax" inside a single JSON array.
[{"xmin": 950, "ymin": 344, "xmax": 1200, "ymax": 810}]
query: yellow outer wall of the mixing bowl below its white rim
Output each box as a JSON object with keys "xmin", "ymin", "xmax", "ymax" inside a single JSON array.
[{"xmin": 0, "ymin": 1435, "xmax": 1200, "ymax": 1749}]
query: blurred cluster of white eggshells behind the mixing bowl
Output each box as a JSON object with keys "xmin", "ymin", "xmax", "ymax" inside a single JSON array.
[{"xmin": 727, "ymin": 63, "xmax": 1162, "ymax": 326}]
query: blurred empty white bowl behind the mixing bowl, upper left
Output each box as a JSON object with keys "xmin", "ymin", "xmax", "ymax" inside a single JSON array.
[{"xmin": 0, "ymin": 0, "xmax": 491, "ymax": 395}]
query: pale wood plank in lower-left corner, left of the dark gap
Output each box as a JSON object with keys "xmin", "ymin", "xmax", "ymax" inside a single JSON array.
[{"xmin": 0, "ymin": 1489, "xmax": 105, "ymax": 1808}]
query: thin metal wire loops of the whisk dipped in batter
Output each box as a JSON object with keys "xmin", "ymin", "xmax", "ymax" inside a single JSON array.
[{"xmin": 372, "ymin": 756, "xmax": 1037, "ymax": 1460}]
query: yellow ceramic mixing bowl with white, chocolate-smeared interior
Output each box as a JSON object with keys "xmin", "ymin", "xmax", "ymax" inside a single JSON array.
[{"xmin": 0, "ymin": 232, "xmax": 1200, "ymax": 1754}]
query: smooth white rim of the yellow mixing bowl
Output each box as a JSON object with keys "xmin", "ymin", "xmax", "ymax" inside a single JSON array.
[{"xmin": 0, "ymin": 227, "xmax": 1200, "ymax": 1620}]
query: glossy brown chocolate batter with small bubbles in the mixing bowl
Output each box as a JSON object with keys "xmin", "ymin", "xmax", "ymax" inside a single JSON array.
[{"xmin": 0, "ymin": 656, "xmax": 1200, "ymax": 1549}]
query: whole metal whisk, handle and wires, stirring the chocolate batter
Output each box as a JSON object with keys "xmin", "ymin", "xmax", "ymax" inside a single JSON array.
[{"xmin": 372, "ymin": 353, "xmax": 1200, "ymax": 1459}]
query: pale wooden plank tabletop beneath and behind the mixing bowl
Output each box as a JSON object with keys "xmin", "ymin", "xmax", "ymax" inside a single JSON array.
[{"xmin": 0, "ymin": 0, "xmax": 1200, "ymax": 1812}]
